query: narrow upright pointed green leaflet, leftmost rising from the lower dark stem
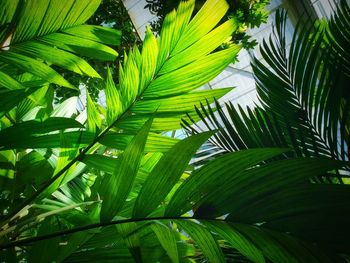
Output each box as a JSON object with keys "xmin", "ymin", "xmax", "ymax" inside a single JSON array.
[{"xmin": 100, "ymin": 119, "xmax": 152, "ymax": 221}]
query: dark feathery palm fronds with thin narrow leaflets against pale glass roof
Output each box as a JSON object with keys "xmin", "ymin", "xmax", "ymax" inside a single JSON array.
[{"xmin": 183, "ymin": 4, "xmax": 350, "ymax": 173}]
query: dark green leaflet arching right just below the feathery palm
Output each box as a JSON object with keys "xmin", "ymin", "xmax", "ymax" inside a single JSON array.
[{"xmin": 219, "ymin": 158, "xmax": 345, "ymax": 222}]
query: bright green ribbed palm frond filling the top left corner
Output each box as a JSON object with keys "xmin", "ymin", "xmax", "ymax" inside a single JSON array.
[{"xmin": 0, "ymin": 0, "xmax": 120, "ymax": 90}]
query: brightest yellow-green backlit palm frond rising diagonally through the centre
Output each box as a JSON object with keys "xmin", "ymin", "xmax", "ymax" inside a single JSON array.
[{"xmin": 1, "ymin": 0, "xmax": 239, "ymax": 210}]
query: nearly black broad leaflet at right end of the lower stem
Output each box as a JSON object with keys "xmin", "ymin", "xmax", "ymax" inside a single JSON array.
[{"xmin": 250, "ymin": 184, "xmax": 350, "ymax": 242}]
